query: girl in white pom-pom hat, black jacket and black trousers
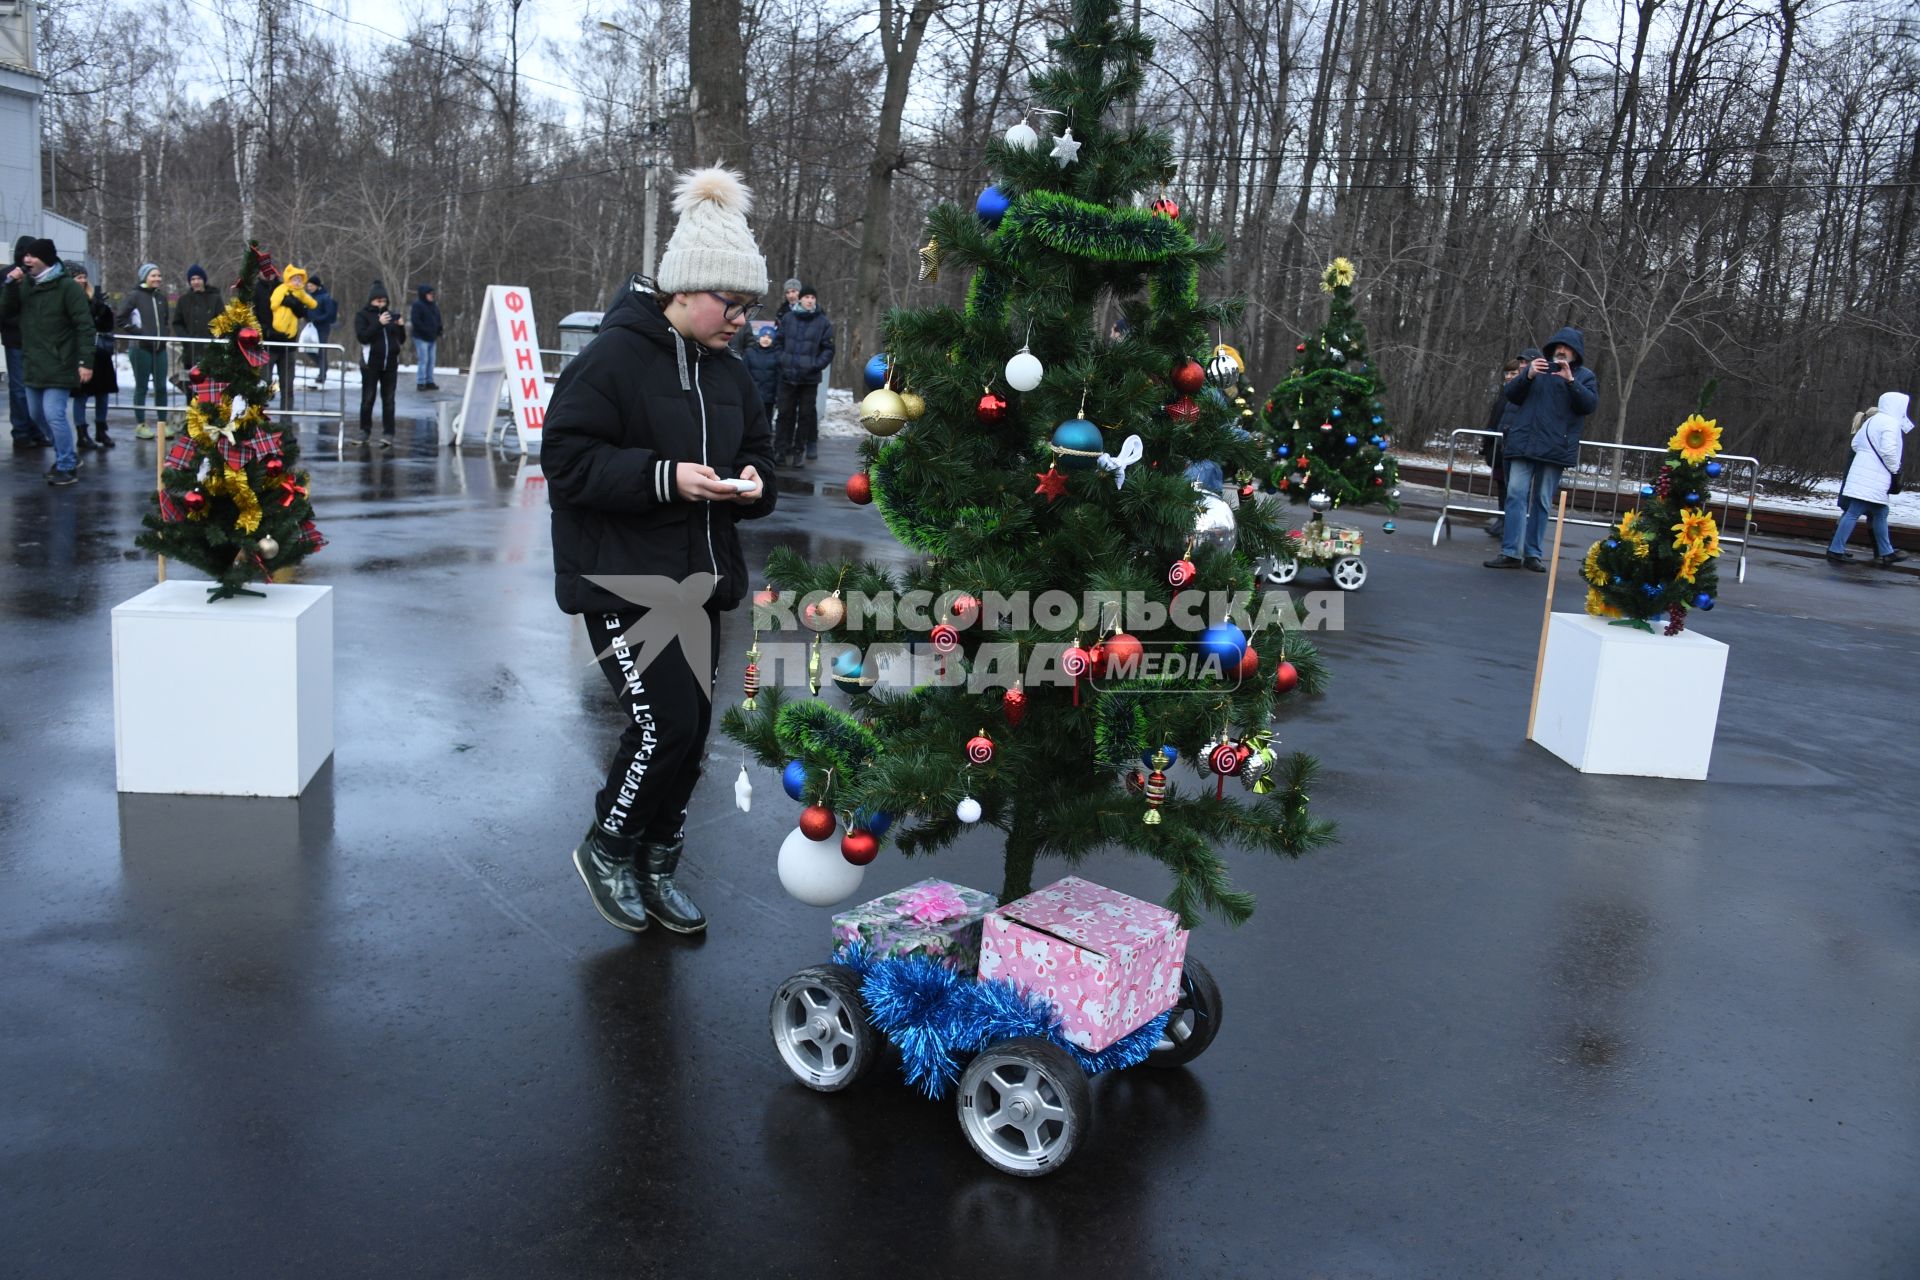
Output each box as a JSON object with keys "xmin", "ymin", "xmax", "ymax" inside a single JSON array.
[{"xmin": 540, "ymin": 169, "xmax": 774, "ymax": 933}]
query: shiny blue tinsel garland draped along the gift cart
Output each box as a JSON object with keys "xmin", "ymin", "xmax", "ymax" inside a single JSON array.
[{"xmin": 833, "ymin": 944, "xmax": 1167, "ymax": 1098}]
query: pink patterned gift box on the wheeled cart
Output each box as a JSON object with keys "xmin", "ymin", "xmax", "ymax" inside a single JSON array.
[{"xmin": 979, "ymin": 875, "xmax": 1187, "ymax": 1052}]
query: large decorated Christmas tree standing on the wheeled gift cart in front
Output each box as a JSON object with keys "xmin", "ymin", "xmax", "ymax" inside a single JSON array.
[{"xmin": 724, "ymin": 0, "xmax": 1332, "ymax": 923}]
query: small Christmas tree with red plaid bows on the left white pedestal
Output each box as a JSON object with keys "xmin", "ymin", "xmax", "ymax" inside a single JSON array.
[{"xmin": 134, "ymin": 242, "xmax": 326, "ymax": 601}]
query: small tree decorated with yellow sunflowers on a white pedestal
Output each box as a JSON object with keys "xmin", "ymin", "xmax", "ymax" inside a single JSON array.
[{"xmin": 1580, "ymin": 415, "xmax": 1720, "ymax": 635}]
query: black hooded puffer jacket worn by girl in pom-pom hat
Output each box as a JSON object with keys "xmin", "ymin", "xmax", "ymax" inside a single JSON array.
[{"xmin": 540, "ymin": 292, "xmax": 774, "ymax": 614}]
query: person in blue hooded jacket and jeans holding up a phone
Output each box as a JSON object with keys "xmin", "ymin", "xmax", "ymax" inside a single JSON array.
[{"xmin": 1486, "ymin": 326, "xmax": 1599, "ymax": 574}]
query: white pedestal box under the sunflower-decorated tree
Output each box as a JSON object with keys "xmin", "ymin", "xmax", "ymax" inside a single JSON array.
[{"xmin": 1534, "ymin": 614, "xmax": 1726, "ymax": 779}]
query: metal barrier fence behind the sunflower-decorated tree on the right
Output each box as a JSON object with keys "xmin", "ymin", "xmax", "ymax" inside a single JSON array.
[{"xmin": 1432, "ymin": 426, "xmax": 1761, "ymax": 581}]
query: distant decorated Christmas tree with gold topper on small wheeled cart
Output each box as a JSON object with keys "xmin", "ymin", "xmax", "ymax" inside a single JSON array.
[{"xmin": 1263, "ymin": 257, "xmax": 1400, "ymax": 510}]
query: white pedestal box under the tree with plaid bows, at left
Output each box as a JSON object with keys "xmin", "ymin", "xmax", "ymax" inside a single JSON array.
[{"xmin": 113, "ymin": 580, "xmax": 334, "ymax": 796}]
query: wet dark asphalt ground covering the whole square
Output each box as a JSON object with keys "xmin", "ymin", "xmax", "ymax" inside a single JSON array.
[{"xmin": 0, "ymin": 385, "xmax": 1920, "ymax": 1278}]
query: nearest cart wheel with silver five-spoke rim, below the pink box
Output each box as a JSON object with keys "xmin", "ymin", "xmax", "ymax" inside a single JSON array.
[{"xmin": 954, "ymin": 1036, "xmax": 1092, "ymax": 1178}]
